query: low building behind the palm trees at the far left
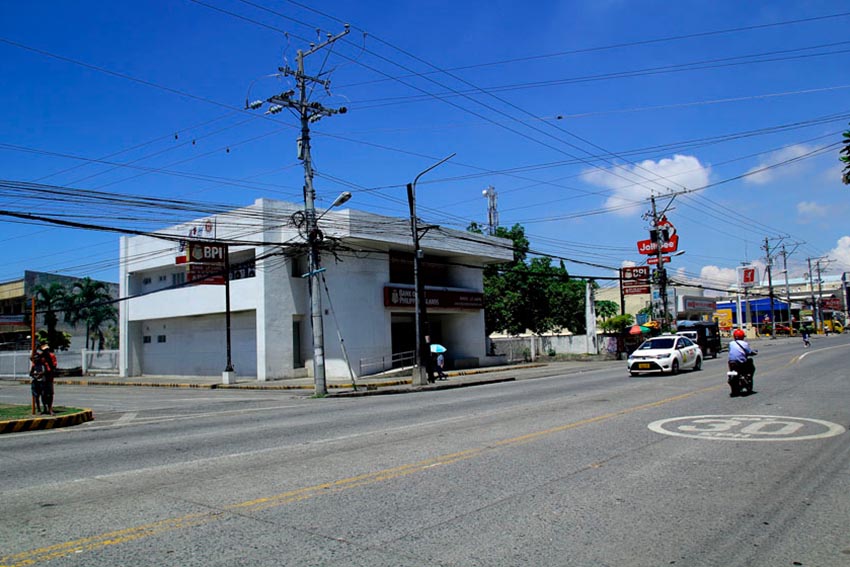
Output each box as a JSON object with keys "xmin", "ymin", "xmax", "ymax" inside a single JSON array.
[{"xmin": 0, "ymin": 270, "xmax": 118, "ymax": 351}]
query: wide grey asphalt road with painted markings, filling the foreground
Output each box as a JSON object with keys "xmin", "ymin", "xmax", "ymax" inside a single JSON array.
[{"xmin": 0, "ymin": 336, "xmax": 850, "ymax": 567}]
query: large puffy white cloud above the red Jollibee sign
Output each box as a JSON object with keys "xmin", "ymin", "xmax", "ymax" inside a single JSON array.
[{"xmin": 582, "ymin": 154, "xmax": 710, "ymax": 217}]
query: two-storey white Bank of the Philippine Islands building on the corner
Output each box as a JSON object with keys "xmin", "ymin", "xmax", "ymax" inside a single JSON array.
[{"xmin": 120, "ymin": 199, "xmax": 513, "ymax": 381}]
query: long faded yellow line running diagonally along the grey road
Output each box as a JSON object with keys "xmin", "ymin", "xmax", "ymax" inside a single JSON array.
[{"xmin": 0, "ymin": 384, "xmax": 725, "ymax": 567}]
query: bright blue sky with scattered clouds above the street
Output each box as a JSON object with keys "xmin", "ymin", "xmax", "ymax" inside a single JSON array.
[{"xmin": 0, "ymin": 0, "xmax": 850, "ymax": 298}]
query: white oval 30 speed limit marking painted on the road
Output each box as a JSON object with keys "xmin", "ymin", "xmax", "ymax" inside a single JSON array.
[{"xmin": 648, "ymin": 415, "xmax": 846, "ymax": 441}]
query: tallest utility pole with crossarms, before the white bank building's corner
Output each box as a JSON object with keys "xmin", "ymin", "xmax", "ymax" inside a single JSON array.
[{"xmin": 246, "ymin": 24, "xmax": 350, "ymax": 395}]
